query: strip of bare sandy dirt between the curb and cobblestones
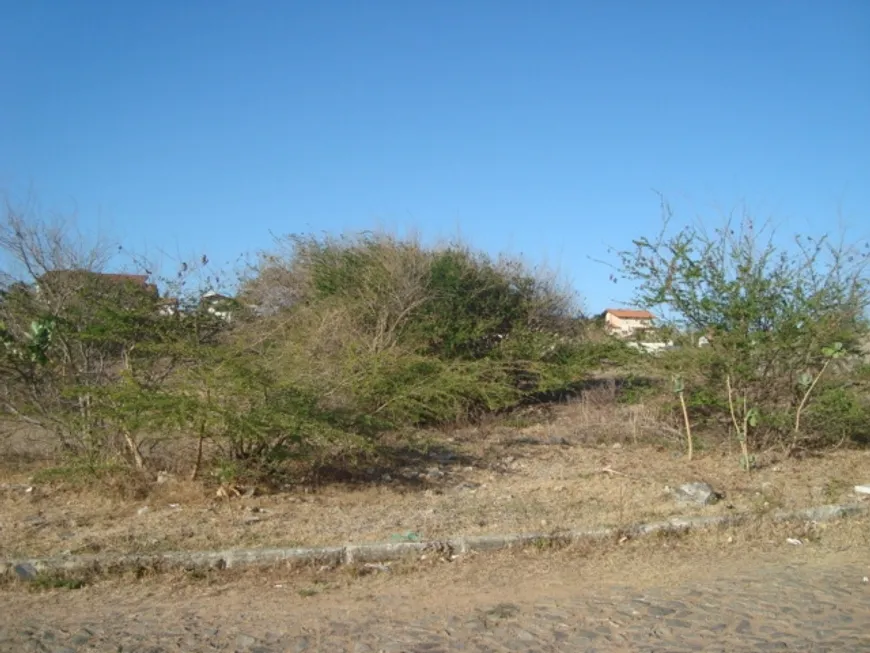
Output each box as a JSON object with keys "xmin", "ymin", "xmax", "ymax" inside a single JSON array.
[{"xmin": 0, "ymin": 510, "xmax": 870, "ymax": 625}]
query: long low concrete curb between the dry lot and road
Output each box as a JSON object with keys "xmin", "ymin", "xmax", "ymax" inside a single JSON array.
[{"xmin": 0, "ymin": 503, "xmax": 870, "ymax": 577}]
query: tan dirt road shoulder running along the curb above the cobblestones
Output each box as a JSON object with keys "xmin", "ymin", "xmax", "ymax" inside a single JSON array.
[{"xmin": 10, "ymin": 514, "xmax": 870, "ymax": 616}]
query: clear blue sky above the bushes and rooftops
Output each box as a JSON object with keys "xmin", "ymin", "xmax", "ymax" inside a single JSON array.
[{"xmin": 0, "ymin": 0, "xmax": 870, "ymax": 311}]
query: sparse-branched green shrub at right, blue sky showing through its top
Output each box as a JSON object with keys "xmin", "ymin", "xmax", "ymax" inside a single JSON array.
[{"xmin": 619, "ymin": 209, "xmax": 870, "ymax": 450}]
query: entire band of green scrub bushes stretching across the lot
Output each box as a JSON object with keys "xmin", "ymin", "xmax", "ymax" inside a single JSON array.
[{"xmin": 0, "ymin": 199, "xmax": 870, "ymax": 487}]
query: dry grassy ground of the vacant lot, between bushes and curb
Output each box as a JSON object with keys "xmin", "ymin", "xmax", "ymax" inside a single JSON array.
[{"xmin": 0, "ymin": 398, "xmax": 870, "ymax": 559}]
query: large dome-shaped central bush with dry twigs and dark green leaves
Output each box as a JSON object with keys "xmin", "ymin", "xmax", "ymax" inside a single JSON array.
[{"xmin": 243, "ymin": 230, "xmax": 604, "ymax": 444}]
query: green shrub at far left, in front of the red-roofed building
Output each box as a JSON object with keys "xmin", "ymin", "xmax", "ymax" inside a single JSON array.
[{"xmin": 0, "ymin": 243, "xmax": 232, "ymax": 464}]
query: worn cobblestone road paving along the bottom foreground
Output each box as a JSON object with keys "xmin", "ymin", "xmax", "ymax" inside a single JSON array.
[{"xmin": 0, "ymin": 553, "xmax": 870, "ymax": 653}]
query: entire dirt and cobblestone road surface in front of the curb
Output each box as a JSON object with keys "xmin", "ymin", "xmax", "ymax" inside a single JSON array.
[{"xmin": 0, "ymin": 518, "xmax": 870, "ymax": 653}]
